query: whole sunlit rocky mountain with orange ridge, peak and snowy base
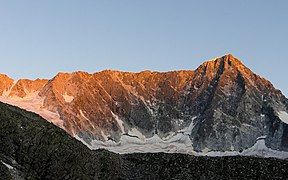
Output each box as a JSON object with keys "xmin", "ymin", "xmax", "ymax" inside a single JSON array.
[{"xmin": 0, "ymin": 54, "xmax": 288, "ymax": 157}]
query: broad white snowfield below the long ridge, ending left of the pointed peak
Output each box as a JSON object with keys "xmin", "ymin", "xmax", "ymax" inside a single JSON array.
[{"xmin": 75, "ymin": 117, "xmax": 196, "ymax": 154}]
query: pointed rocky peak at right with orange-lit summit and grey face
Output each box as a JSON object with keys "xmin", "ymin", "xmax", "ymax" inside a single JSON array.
[{"xmin": 185, "ymin": 55, "xmax": 287, "ymax": 151}]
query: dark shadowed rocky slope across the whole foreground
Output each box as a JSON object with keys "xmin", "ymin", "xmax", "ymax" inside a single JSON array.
[{"xmin": 0, "ymin": 100, "xmax": 288, "ymax": 180}]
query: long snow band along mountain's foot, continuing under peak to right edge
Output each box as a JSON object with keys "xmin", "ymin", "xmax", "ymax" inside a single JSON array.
[{"xmin": 75, "ymin": 129, "xmax": 288, "ymax": 159}]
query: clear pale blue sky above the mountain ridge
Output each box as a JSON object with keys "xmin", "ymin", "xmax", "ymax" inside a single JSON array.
[{"xmin": 0, "ymin": 0, "xmax": 288, "ymax": 96}]
